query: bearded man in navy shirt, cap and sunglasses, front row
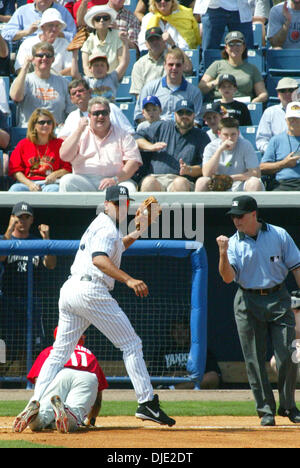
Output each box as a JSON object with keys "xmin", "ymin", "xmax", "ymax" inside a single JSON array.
[{"xmin": 135, "ymin": 99, "xmax": 210, "ymax": 192}]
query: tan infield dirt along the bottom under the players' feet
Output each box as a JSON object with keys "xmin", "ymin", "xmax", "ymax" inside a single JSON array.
[{"xmin": 0, "ymin": 416, "xmax": 300, "ymax": 449}]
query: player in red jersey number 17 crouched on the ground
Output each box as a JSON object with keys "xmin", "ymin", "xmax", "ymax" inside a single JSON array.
[{"xmin": 27, "ymin": 328, "xmax": 108, "ymax": 432}]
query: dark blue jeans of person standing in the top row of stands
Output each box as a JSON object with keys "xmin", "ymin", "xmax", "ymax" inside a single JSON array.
[{"xmin": 201, "ymin": 8, "xmax": 254, "ymax": 50}]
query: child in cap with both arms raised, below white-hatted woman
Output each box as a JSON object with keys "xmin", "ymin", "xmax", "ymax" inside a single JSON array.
[{"xmin": 71, "ymin": 31, "xmax": 129, "ymax": 101}]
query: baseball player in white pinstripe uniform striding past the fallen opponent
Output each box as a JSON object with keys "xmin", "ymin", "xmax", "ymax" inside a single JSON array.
[{"xmin": 13, "ymin": 186, "xmax": 175, "ymax": 432}]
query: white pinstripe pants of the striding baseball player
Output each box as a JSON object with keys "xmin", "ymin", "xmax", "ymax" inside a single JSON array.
[{"xmin": 33, "ymin": 277, "xmax": 153, "ymax": 403}]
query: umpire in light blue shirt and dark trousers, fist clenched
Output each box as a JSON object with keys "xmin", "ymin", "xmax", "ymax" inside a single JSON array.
[{"xmin": 217, "ymin": 195, "xmax": 300, "ymax": 426}]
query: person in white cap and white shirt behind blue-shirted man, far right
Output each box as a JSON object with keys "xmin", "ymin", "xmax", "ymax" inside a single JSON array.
[{"xmin": 256, "ymin": 77, "xmax": 298, "ymax": 154}]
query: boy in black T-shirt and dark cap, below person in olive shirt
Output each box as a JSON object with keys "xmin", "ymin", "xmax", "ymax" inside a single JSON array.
[{"xmin": 218, "ymin": 74, "xmax": 252, "ymax": 126}]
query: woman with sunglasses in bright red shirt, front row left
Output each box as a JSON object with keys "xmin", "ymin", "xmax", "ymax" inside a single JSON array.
[{"xmin": 9, "ymin": 108, "xmax": 72, "ymax": 192}]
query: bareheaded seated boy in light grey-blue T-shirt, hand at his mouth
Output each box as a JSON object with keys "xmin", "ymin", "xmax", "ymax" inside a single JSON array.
[{"xmin": 195, "ymin": 117, "xmax": 265, "ymax": 192}]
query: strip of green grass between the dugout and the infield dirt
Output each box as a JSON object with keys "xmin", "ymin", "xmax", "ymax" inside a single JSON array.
[{"xmin": 0, "ymin": 401, "xmax": 256, "ymax": 417}]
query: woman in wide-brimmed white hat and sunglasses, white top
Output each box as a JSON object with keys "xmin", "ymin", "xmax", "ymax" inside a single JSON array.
[{"xmin": 81, "ymin": 5, "xmax": 123, "ymax": 76}]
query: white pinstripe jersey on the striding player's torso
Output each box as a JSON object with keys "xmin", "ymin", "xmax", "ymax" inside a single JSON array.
[{"xmin": 71, "ymin": 213, "xmax": 125, "ymax": 290}]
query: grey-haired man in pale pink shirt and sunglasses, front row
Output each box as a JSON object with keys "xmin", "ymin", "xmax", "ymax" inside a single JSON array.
[{"xmin": 59, "ymin": 96, "xmax": 142, "ymax": 193}]
